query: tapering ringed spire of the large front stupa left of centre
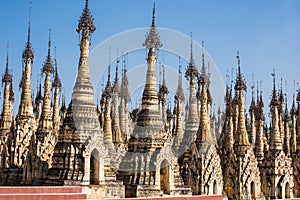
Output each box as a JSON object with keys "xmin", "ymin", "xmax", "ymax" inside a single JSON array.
[{"xmin": 67, "ymin": 1, "xmax": 100, "ymax": 137}]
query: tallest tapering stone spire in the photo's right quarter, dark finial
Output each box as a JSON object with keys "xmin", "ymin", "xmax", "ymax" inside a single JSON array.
[{"xmin": 235, "ymin": 52, "xmax": 250, "ymax": 155}]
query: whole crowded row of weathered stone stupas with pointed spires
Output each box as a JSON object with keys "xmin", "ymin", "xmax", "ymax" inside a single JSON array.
[{"xmin": 0, "ymin": 0, "xmax": 300, "ymax": 199}]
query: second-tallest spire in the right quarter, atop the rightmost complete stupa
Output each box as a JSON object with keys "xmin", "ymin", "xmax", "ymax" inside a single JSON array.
[{"xmin": 270, "ymin": 70, "xmax": 282, "ymax": 151}]
